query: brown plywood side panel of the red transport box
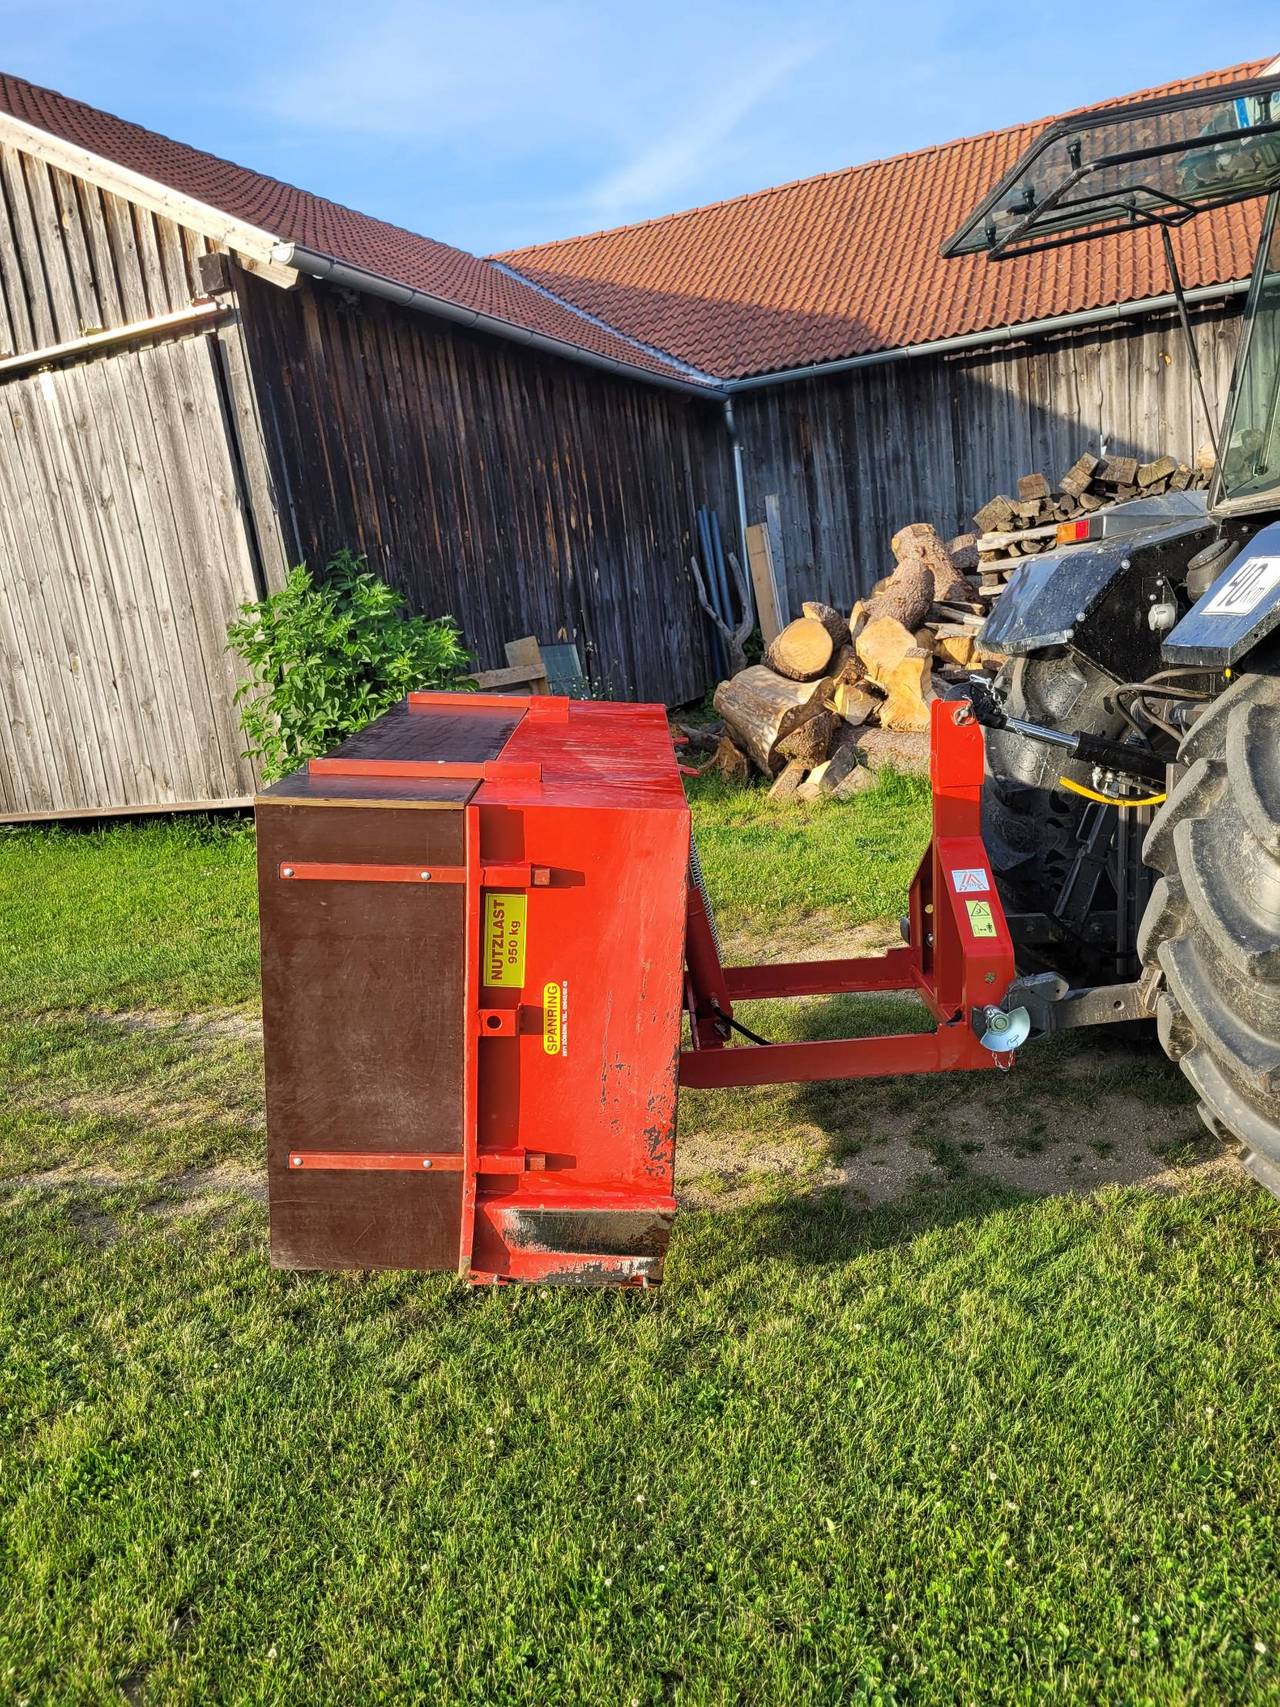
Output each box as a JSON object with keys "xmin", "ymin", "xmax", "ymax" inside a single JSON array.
[{"xmin": 258, "ymin": 802, "xmax": 466, "ymax": 1268}]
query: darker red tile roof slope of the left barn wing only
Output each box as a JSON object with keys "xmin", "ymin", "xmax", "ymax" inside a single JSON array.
[{"xmin": 0, "ymin": 72, "xmax": 713, "ymax": 379}]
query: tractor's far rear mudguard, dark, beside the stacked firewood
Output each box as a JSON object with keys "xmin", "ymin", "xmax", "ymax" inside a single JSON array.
[{"xmin": 983, "ymin": 510, "xmax": 1215, "ymax": 681}]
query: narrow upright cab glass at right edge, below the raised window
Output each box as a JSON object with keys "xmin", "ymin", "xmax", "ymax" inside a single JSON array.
[{"xmin": 1213, "ymin": 200, "xmax": 1280, "ymax": 507}]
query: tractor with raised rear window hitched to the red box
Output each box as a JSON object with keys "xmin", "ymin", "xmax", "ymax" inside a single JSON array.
[{"xmin": 942, "ymin": 75, "xmax": 1280, "ymax": 1195}]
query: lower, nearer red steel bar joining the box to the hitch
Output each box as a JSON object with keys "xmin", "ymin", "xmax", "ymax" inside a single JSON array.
[{"xmin": 679, "ymin": 1019, "xmax": 1010, "ymax": 1091}]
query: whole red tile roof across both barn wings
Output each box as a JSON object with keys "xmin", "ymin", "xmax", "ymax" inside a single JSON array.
[{"xmin": 0, "ymin": 61, "xmax": 1266, "ymax": 390}]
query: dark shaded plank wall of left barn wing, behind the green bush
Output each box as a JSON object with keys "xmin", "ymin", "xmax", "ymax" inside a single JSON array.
[{"xmin": 241, "ymin": 277, "xmax": 734, "ymax": 703}]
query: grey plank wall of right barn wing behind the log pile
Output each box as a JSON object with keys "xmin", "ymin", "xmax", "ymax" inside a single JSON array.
[{"xmin": 734, "ymin": 299, "xmax": 1239, "ymax": 608}]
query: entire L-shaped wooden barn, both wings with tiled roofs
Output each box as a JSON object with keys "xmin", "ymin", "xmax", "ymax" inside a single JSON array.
[{"xmin": 0, "ymin": 65, "xmax": 1263, "ymax": 818}]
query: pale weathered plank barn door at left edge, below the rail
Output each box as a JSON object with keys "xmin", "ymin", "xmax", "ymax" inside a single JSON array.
[{"xmin": 0, "ymin": 335, "xmax": 266, "ymax": 816}]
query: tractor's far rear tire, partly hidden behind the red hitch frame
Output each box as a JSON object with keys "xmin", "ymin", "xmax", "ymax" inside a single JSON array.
[{"xmin": 983, "ymin": 655, "xmax": 1125, "ymax": 985}]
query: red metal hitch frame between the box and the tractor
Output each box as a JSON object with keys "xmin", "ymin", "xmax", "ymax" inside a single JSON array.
[{"xmin": 679, "ymin": 700, "xmax": 1014, "ymax": 1089}]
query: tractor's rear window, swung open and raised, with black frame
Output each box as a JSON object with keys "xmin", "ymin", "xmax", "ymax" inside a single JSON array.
[{"xmin": 942, "ymin": 77, "xmax": 1280, "ymax": 259}]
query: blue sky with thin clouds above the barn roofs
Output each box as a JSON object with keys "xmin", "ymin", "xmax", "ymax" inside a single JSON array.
[{"xmin": 0, "ymin": 0, "xmax": 1280, "ymax": 253}]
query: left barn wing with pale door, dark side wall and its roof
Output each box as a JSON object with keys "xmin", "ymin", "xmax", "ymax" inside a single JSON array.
[{"xmin": 0, "ymin": 77, "xmax": 734, "ymax": 819}]
